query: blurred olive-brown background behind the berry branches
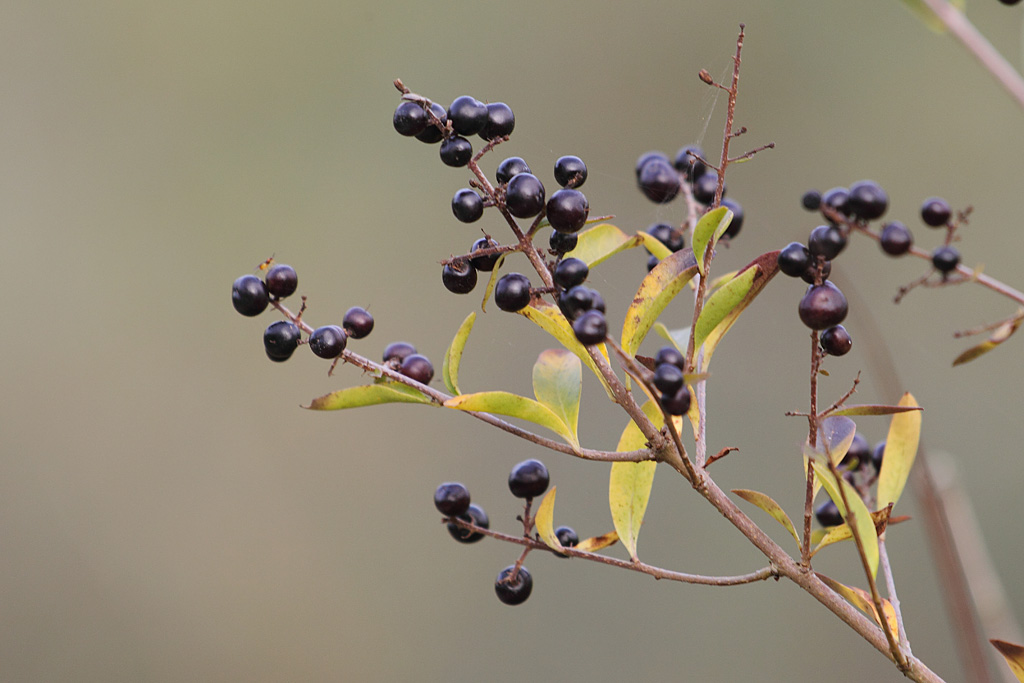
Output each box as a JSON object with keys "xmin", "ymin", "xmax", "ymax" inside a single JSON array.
[{"xmin": 0, "ymin": 0, "xmax": 1024, "ymax": 682}]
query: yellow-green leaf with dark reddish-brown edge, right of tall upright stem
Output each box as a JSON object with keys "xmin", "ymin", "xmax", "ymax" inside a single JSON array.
[{"xmin": 693, "ymin": 251, "xmax": 778, "ymax": 370}]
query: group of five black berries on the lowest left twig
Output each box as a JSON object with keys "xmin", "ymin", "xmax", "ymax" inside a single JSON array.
[{"xmin": 434, "ymin": 459, "xmax": 580, "ymax": 605}]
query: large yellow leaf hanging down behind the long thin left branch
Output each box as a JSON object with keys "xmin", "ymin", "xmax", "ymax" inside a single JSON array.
[{"xmin": 608, "ymin": 401, "xmax": 665, "ymax": 561}]
